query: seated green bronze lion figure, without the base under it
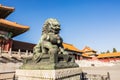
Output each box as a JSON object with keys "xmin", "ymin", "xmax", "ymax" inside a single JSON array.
[{"xmin": 34, "ymin": 18, "xmax": 67, "ymax": 62}]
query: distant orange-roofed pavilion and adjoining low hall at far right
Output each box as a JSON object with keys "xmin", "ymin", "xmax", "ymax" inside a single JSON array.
[{"xmin": 81, "ymin": 46, "xmax": 120, "ymax": 62}]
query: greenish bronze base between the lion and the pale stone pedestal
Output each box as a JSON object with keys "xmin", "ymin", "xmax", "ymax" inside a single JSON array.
[{"xmin": 20, "ymin": 54, "xmax": 79, "ymax": 70}]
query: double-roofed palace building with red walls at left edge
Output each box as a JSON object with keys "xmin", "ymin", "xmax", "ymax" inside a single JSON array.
[{"xmin": 0, "ymin": 4, "xmax": 29, "ymax": 52}]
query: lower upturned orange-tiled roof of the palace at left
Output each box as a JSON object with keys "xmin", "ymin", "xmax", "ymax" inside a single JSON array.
[{"xmin": 0, "ymin": 19, "xmax": 29, "ymax": 37}]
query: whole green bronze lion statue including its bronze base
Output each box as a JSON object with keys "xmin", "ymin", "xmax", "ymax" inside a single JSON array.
[{"xmin": 21, "ymin": 18, "xmax": 78, "ymax": 70}]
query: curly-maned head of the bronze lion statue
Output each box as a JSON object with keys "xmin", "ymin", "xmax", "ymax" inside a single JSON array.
[{"xmin": 42, "ymin": 18, "xmax": 60, "ymax": 34}]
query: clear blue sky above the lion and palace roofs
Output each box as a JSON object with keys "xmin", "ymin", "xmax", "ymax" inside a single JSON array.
[{"xmin": 0, "ymin": 0, "xmax": 120, "ymax": 53}]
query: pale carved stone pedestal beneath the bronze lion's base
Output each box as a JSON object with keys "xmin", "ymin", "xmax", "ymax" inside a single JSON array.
[{"xmin": 16, "ymin": 68, "xmax": 82, "ymax": 80}]
